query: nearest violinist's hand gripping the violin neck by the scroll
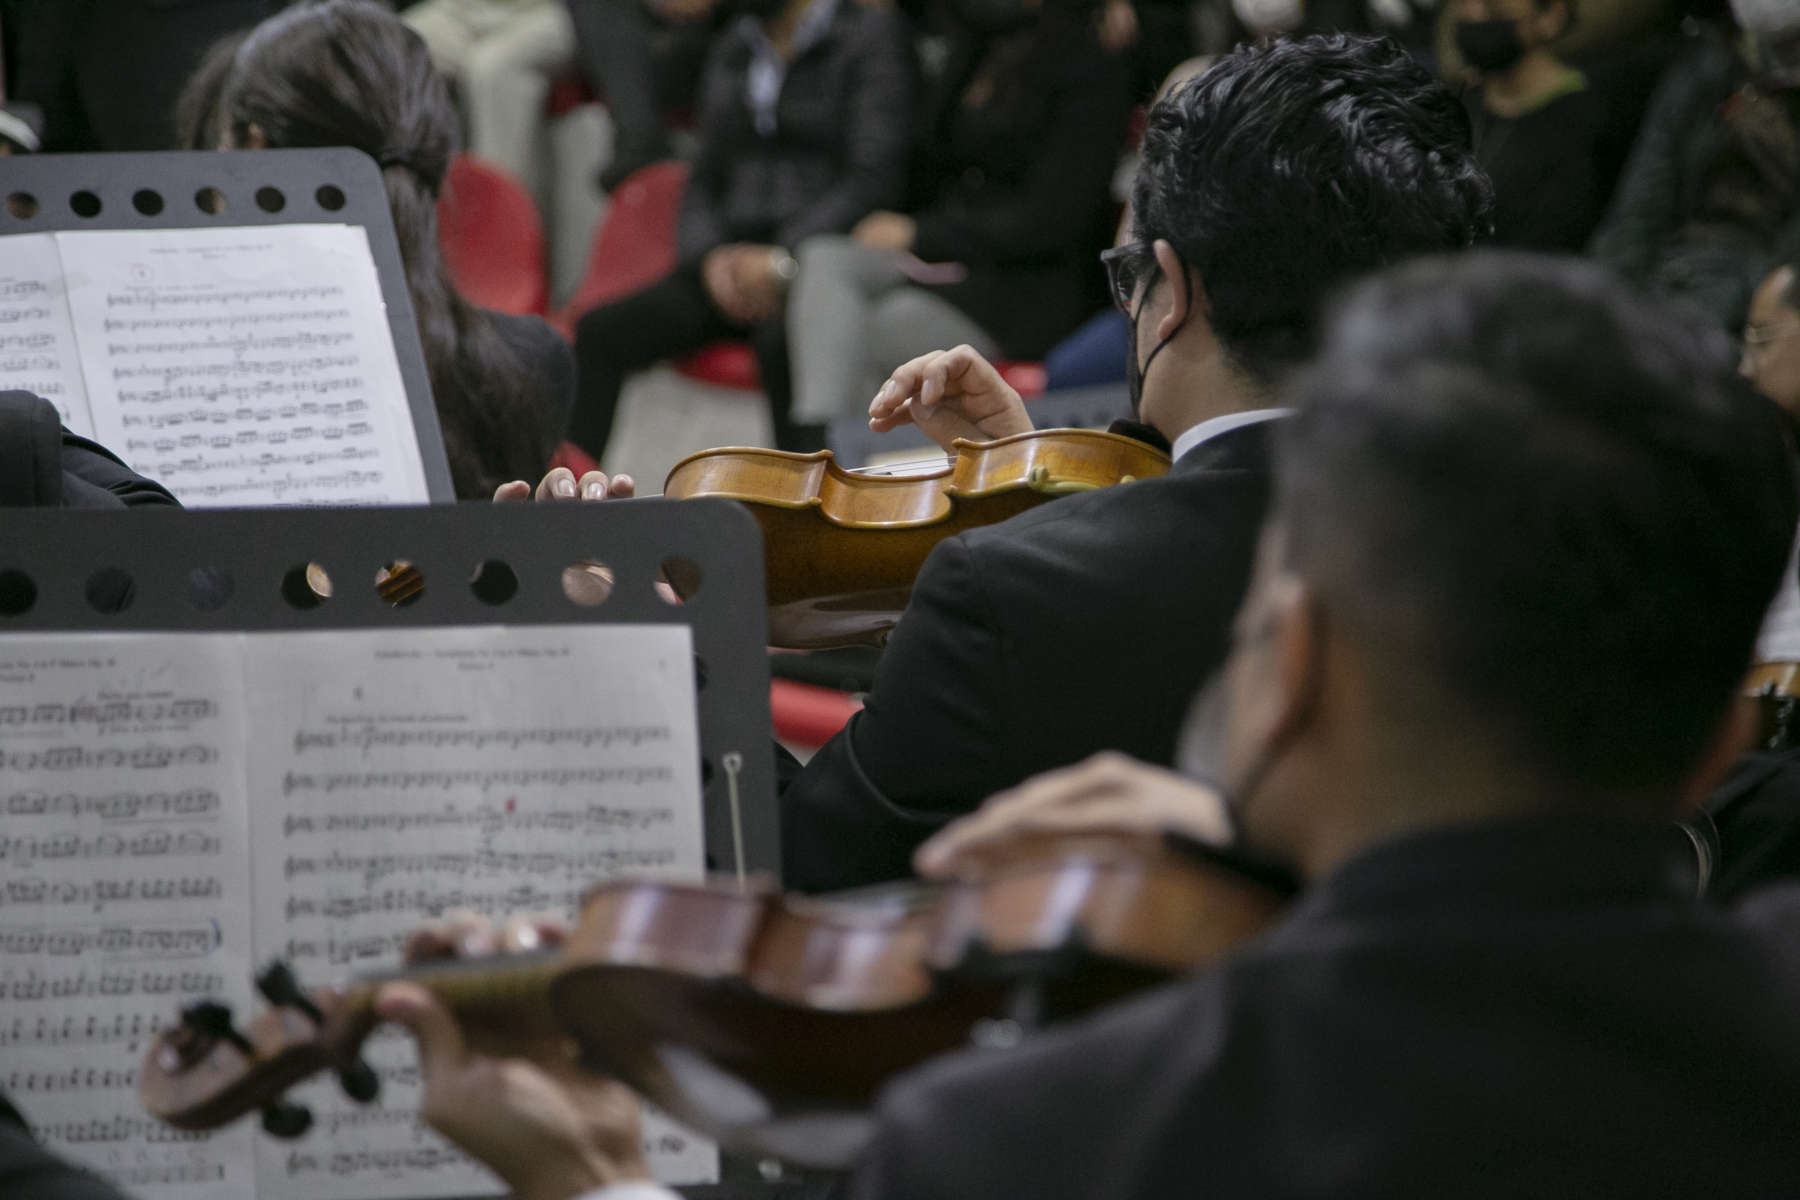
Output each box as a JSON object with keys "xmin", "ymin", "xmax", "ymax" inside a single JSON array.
[{"xmin": 376, "ymin": 914, "xmax": 650, "ymax": 1200}]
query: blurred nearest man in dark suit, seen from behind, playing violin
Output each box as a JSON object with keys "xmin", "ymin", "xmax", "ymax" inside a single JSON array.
[{"xmin": 383, "ymin": 255, "xmax": 1800, "ymax": 1200}]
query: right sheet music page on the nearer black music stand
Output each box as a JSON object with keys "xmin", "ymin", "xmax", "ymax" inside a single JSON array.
[{"xmin": 245, "ymin": 626, "xmax": 718, "ymax": 1200}]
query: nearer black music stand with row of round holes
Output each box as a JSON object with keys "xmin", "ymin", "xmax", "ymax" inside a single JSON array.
[{"xmin": 0, "ymin": 500, "xmax": 819, "ymax": 1200}]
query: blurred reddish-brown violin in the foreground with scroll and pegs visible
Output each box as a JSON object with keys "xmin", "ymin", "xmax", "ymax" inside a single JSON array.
[{"xmin": 139, "ymin": 835, "xmax": 1292, "ymax": 1168}]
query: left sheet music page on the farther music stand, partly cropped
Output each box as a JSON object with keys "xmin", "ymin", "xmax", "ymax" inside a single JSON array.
[{"xmin": 0, "ymin": 234, "xmax": 94, "ymax": 437}]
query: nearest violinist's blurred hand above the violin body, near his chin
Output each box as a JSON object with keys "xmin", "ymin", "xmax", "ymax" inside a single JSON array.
[{"xmin": 913, "ymin": 752, "xmax": 1231, "ymax": 878}]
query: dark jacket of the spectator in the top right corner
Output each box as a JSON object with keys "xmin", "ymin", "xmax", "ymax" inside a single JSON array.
[{"xmin": 1589, "ymin": 27, "xmax": 1800, "ymax": 333}]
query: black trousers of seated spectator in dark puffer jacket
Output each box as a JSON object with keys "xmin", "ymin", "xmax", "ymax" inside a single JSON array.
[{"xmin": 569, "ymin": 263, "xmax": 792, "ymax": 459}]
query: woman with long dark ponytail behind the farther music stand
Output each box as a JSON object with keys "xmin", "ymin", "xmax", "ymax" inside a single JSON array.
[{"xmin": 194, "ymin": 0, "xmax": 574, "ymax": 500}]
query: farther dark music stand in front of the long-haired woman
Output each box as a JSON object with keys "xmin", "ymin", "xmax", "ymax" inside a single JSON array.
[{"xmin": 0, "ymin": 148, "xmax": 455, "ymax": 502}]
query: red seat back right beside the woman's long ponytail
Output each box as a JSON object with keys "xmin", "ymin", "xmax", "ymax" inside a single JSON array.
[{"xmin": 437, "ymin": 155, "xmax": 549, "ymax": 315}]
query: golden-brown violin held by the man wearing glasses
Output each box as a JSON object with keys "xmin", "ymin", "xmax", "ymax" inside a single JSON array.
[{"xmin": 662, "ymin": 430, "xmax": 1170, "ymax": 649}]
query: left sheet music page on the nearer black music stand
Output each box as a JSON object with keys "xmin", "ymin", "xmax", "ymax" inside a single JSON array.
[{"xmin": 0, "ymin": 633, "xmax": 256, "ymax": 1200}]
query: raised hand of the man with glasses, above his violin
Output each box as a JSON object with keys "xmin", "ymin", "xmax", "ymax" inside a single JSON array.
[{"xmin": 869, "ymin": 345, "xmax": 1031, "ymax": 450}]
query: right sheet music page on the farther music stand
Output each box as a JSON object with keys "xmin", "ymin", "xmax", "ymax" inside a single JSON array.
[{"xmin": 56, "ymin": 225, "xmax": 428, "ymax": 507}]
